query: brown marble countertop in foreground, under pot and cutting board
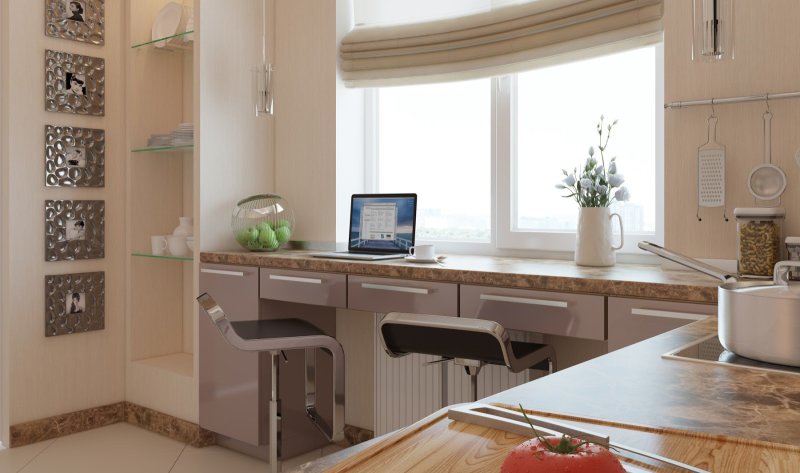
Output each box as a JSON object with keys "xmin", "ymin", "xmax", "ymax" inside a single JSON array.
[{"xmin": 295, "ymin": 317, "xmax": 800, "ymax": 473}]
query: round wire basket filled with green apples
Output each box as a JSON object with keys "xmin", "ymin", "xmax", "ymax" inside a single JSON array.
[{"xmin": 231, "ymin": 194, "xmax": 294, "ymax": 251}]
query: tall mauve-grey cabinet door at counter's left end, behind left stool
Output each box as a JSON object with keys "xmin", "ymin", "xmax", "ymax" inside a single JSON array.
[{"xmin": 198, "ymin": 264, "xmax": 267, "ymax": 445}]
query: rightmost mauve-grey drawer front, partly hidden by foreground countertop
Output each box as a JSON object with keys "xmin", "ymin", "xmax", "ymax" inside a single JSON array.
[{"xmin": 608, "ymin": 297, "xmax": 717, "ymax": 351}]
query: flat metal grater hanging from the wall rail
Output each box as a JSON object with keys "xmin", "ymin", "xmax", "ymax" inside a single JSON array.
[{"xmin": 697, "ymin": 114, "xmax": 728, "ymax": 222}]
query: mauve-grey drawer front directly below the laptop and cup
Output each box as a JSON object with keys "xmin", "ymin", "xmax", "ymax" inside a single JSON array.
[{"xmin": 347, "ymin": 276, "xmax": 458, "ymax": 317}]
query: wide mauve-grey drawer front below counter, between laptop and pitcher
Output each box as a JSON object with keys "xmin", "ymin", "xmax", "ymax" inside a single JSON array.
[{"xmin": 461, "ymin": 285, "xmax": 606, "ymax": 340}]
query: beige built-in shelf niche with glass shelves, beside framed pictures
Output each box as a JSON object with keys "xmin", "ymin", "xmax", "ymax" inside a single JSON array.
[{"xmin": 125, "ymin": 0, "xmax": 199, "ymax": 422}]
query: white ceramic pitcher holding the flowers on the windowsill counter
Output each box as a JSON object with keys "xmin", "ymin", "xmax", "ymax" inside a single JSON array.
[{"xmin": 575, "ymin": 207, "xmax": 625, "ymax": 266}]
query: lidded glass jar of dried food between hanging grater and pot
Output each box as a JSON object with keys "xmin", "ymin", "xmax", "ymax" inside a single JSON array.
[{"xmin": 733, "ymin": 207, "xmax": 786, "ymax": 278}]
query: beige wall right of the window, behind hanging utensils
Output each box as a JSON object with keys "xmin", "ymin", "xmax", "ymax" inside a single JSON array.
[{"xmin": 664, "ymin": 0, "xmax": 800, "ymax": 259}]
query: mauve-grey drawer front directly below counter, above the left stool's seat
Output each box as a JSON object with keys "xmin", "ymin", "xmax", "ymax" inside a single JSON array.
[{"xmin": 260, "ymin": 268, "xmax": 347, "ymax": 308}]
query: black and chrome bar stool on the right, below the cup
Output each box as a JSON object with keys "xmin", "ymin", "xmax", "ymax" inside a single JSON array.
[{"xmin": 379, "ymin": 312, "xmax": 556, "ymax": 406}]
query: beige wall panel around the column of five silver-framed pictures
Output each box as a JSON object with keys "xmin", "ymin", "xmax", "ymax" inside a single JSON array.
[{"xmin": 0, "ymin": 0, "xmax": 125, "ymax": 424}]
